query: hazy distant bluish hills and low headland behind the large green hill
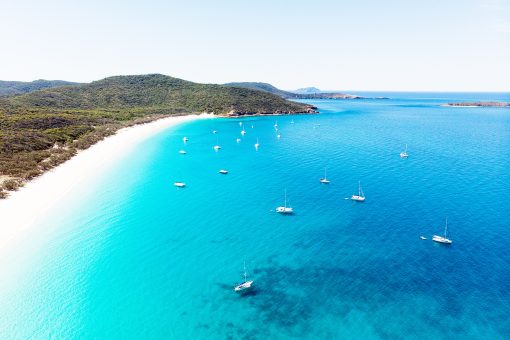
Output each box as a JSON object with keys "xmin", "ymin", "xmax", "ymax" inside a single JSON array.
[{"xmin": 225, "ymin": 82, "xmax": 388, "ymax": 99}]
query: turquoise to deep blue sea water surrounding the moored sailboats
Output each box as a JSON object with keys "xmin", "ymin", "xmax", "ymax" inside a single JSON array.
[{"xmin": 0, "ymin": 93, "xmax": 510, "ymax": 339}]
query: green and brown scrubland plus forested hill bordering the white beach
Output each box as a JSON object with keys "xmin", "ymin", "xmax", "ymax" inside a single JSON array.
[{"xmin": 0, "ymin": 74, "xmax": 314, "ymax": 197}]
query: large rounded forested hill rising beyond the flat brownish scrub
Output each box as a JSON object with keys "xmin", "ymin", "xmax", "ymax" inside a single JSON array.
[{"xmin": 10, "ymin": 74, "xmax": 310, "ymax": 114}]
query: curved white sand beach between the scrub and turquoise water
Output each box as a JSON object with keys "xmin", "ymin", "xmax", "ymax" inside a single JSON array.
[{"xmin": 0, "ymin": 114, "xmax": 212, "ymax": 249}]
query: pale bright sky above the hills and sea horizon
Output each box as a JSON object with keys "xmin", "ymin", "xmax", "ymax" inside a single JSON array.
[{"xmin": 0, "ymin": 0, "xmax": 510, "ymax": 92}]
